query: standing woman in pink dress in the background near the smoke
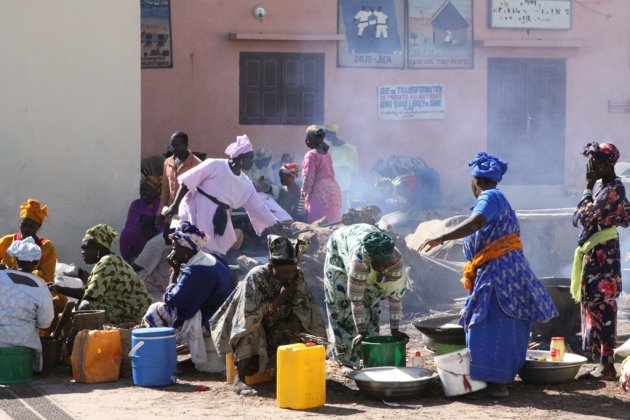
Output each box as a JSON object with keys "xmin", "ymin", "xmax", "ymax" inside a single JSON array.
[{"xmin": 302, "ymin": 125, "xmax": 341, "ymax": 223}]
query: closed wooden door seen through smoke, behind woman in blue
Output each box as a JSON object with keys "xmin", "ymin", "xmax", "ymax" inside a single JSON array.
[{"xmin": 488, "ymin": 58, "xmax": 566, "ymax": 185}]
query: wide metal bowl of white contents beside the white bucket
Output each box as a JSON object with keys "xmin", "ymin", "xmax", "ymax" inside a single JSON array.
[{"xmin": 348, "ymin": 366, "xmax": 438, "ymax": 400}]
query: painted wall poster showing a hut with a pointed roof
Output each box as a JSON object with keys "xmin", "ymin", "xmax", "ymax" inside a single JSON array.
[{"xmin": 407, "ymin": 0, "xmax": 475, "ymax": 69}]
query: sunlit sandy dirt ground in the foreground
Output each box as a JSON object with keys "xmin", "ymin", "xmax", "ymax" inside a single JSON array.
[{"xmin": 0, "ymin": 295, "xmax": 630, "ymax": 419}]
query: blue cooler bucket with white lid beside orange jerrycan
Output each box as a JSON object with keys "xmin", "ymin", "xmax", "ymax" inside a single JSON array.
[{"xmin": 129, "ymin": 328, "xmax": 177, "ymax": 386}]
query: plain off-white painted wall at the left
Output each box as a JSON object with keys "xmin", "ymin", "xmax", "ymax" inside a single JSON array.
[{"xmin": 0, "ymin": 0, "xmax": 140, "ymax": 264}]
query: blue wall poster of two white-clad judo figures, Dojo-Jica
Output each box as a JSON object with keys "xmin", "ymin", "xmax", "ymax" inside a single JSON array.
[{"xmin": 337, "ymin": 0, "xmax": 405, "ymax": 68}]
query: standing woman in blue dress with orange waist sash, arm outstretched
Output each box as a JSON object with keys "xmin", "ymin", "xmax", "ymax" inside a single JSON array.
[{"xmin": 420, "ymin": 152, "xmax": 558, "ymax": 397}]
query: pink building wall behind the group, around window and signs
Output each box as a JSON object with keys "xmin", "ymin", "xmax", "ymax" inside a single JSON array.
[{"xmin": 142, "ymin": 0, "xmax": 630, "ymax": 203}]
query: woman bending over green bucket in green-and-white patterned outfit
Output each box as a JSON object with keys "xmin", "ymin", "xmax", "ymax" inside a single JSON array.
[{"xmin": 324, "ymin": 223, "xmax": 409, "ymax": 367}]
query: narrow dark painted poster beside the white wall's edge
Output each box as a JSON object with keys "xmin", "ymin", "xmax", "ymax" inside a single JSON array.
[{"xmin": 140, "ymin": 0, "xmax": 173, "ymax": 68}]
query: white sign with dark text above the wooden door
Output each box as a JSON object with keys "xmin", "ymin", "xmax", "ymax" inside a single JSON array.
[{"xmin": 488, "ymin": 0, "xmax": 571, "ymax": 29}]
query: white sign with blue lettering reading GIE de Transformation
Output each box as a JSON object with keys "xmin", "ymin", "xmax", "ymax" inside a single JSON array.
[{"xmin": 378, "ymin": 84, "xmax": 445, "ymax": 120}]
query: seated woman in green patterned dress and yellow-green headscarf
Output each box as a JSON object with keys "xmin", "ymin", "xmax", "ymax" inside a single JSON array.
[{"xmin": 49, "ymin": 224, "xmax": 153, "ymax": 325}]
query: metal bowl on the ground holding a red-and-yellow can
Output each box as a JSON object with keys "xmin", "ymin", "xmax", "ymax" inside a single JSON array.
[{"xmin": 518, "ymin": 350, "xmax": 587, "ymax": 385}]
